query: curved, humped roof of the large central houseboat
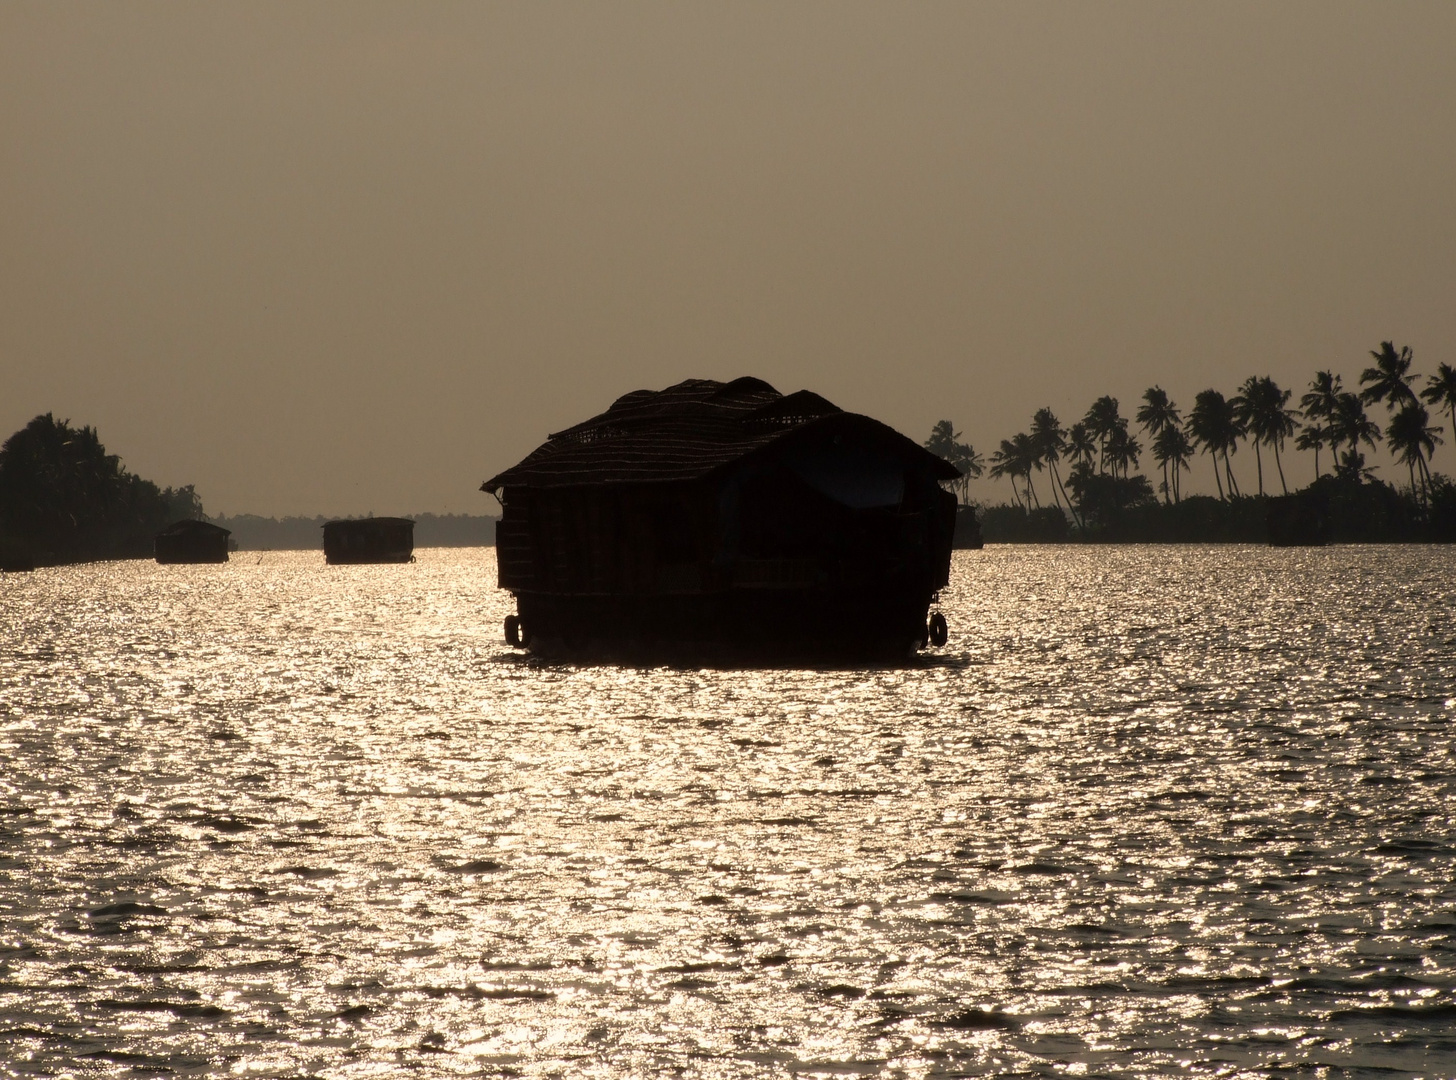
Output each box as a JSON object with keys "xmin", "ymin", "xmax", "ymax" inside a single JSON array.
[{"xmin": 480, "ymin": 377, "xmax": 960, "ymax": 495}]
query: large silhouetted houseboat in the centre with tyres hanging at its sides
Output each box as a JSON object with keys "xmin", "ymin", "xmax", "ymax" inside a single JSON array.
[{"xmin": 482, "ymin": 378, "xmax": 960, "ymax": 661}]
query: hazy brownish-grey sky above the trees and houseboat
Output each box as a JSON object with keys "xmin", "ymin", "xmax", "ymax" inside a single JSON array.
[{"xmin": 0, "ymin": 0, "xmax": 1456, "ymax": 514}]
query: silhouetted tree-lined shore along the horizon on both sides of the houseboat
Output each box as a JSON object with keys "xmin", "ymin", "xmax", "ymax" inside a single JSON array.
[{"xmin": 11, "ymin": 342, "xmax": 1456, "ymax": 566}]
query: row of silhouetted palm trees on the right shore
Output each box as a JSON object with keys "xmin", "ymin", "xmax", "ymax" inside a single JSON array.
[{"xmin": 925, "ymin": 342, "xmax": 1456, "ymax": 540}]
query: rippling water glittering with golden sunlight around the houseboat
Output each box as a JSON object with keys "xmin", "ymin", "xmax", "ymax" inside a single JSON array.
[{"xmin": 0, "ymin": 547, "xmax": 1456, "ymax": 1077}]
